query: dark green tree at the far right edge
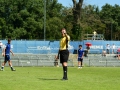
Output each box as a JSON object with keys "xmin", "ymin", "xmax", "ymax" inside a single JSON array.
[{"xmin": 100, "ymin": 4, "xmax": 120, "ymax": 40}]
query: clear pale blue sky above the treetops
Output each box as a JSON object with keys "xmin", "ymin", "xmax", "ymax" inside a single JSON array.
[{"xmin": 58, "ymin": 0, "xmax": 120, "ymax": 8}]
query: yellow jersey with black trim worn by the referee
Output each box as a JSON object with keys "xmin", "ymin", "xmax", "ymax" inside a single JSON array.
[{"xmin": 60, "ymin": 35, "xmax": 70, "ymax": 50}]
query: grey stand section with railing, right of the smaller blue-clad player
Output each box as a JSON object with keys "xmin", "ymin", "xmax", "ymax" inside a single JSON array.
[{"xmin": 84, "ymin": 54, "xmax": 120, "ymax": 67}]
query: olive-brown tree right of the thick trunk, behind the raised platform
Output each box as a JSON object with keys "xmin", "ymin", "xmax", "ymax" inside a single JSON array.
[{"xmin": 81, "ymin": 5, "xmax": 105, "ymax": 38}]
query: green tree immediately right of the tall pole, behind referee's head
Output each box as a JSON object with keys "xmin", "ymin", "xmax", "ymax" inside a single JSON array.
[{"xmin": 46, "ymin": 0, "xmax": 65, "ymax": 40}]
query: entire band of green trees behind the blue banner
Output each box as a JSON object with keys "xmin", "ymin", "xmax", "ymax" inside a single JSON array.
[{"xmin": 0, "ymin": 0, "xmax": 120, "ymax": 40}]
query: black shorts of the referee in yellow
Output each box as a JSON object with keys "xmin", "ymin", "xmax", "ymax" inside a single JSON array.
[{"xmin": 60, "ymin": 50, "xmax": 69, "ymax": 63}]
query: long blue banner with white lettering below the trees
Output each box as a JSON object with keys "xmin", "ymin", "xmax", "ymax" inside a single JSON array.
[{"xmin": 1, "ymin": 40, "xmax": 120, "ymax": 54}]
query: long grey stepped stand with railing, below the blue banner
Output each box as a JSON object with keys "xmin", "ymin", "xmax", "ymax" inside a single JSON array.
[{"xmin": 0, "ymin": 53, "xmax": 120, "ymax": 67}]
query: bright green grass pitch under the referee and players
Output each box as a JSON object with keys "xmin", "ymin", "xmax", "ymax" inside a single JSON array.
[{"xmin": 0, "ymin": 67, "xmax": 120, "ymax": 90}]
